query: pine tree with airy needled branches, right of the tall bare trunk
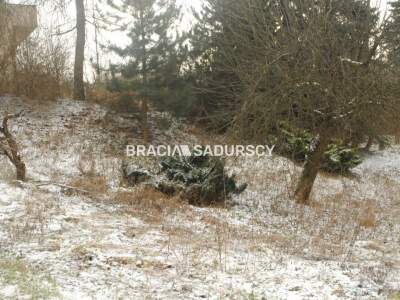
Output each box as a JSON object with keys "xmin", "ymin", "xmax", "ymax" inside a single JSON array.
[{"xmin": 110, "ymin": 0, "xmax": 187, "ymax": 117}]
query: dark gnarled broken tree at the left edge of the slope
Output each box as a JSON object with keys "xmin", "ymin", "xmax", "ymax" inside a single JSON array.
[{"xmin": 0, "ymin": 112, "xmax": 26, "ymax": 181}]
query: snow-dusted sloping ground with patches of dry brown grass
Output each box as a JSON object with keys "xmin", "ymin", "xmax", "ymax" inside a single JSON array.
[{"xmin": 0, "ymin": 97, "xmax": 400, "ymax": 299}]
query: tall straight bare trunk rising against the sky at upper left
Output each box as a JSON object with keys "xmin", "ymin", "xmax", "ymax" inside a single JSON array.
[{"xmin": 74, "ymin": 0, "xmax": 86, "ymax": 100}]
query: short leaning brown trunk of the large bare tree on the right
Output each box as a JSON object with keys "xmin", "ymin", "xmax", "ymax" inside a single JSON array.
[{"xmin": 295, "ymin": 136, "xmax": 329, "ymax": 205}]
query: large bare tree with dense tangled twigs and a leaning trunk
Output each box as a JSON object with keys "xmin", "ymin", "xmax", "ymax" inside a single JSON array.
[{"xmin": 196, "ymin": 0, "xmax": 399, "ymax": 204}]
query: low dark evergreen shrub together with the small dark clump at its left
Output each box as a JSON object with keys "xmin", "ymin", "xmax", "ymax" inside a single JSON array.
[{"xmin": 124, "ymin": 155, "xmax": 247, "ymax": 206}]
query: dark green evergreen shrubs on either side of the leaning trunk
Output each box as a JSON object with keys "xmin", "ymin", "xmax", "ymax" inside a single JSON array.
[{"xmin": 277, "ymin": 124, "xmax": 362, "ymax": 173}]
